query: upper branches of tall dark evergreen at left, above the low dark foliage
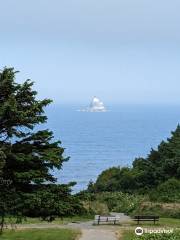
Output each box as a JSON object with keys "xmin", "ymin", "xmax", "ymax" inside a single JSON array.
[{"xmin": 0, "ymin": 68, "xmax": 67, "ymax": 189}]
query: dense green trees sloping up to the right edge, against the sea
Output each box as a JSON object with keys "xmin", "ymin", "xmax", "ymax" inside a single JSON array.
[{"xmin": 91, "ymin": 125, "xmax": 180, "ymax": 199}]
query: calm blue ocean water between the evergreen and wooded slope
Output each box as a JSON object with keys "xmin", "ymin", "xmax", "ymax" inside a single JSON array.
[{"xmin": 44, "ymin": 105, "xmax": 180, "ymax": 192}]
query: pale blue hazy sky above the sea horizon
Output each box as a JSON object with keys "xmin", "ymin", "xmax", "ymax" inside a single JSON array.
[{"xmin": 0, "ymin": 0, "xmax": 180, "ymax": 104}]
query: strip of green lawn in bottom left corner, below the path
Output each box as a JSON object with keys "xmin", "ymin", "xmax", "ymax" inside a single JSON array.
[{"xmin": 0, "ymin": 229, "xmax": 80, "ymax": 240}]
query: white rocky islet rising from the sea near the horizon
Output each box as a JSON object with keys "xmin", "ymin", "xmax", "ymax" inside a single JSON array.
[{"xmin": 80, "ymin": 97, "xmax": 107, "ymax": 112}]
